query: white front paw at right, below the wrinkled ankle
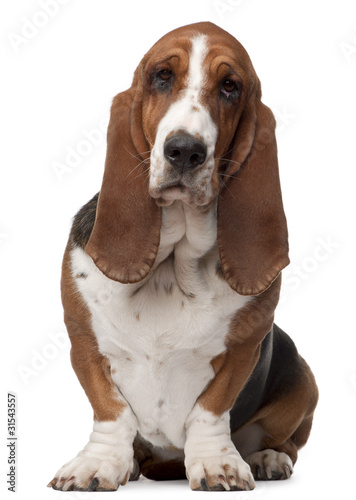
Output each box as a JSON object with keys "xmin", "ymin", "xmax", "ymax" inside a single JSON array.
[{"xmin": 186, "ymin": 452, "xmax": 255, "ymax": 491}]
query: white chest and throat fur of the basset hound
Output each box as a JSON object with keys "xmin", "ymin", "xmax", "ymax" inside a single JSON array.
[{"xmin": 72, "ymin": 203, "xmax": 249, "ymax": 447}]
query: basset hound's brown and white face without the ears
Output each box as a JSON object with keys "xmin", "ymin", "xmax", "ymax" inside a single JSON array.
[{"xmin": 141, "ymin": 26, "xmax": 257, "ymax": 206}]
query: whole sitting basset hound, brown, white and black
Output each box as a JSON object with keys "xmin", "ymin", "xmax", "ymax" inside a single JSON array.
[{"xmin": 49, "ymin": 23, "xmax": 318, "ymax": 491}]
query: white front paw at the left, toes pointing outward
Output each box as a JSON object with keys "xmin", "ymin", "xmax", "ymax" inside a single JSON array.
[{"xmin": 48, "ymin": 451, "xmax": 133, "ymax": 491}]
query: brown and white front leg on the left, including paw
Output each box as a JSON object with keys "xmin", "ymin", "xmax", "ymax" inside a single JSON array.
[{"xmin": 48, "ymin": 251, "xmax": 137, "ymax": 491}]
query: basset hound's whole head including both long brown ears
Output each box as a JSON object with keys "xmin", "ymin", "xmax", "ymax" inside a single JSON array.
[{"xmin": 86, "ymin": 23, "xmax": 289, "ymax": 295}]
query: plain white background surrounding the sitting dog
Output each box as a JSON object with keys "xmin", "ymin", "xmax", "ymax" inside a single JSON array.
[{"xmin": 0, "ymin": 0, "xmax": 356, "ymax": 500}]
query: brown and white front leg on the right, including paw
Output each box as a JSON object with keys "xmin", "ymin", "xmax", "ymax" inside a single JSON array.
[{"xmin": 184, "ymin": 279, "xmax": 280, "ymax": 490}]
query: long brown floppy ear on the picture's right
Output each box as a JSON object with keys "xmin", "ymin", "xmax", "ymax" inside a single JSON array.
[{"xmin": 218, "ymin": 94, "xmax": 289, "ymax": 295}]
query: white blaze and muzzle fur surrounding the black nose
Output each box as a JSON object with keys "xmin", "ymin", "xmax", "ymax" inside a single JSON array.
[{"xmin": 149, "ymin": 35, "xmax": 217, "ymax": 204}]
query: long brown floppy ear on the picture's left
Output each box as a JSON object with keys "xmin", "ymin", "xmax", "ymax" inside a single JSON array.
[{"xmin": 85, "ymin": 68, "xmax": 161, "ymax": 283}]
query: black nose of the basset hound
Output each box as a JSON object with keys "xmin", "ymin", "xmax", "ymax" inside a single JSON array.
[{"xmin": 163, "ymin": 134, "xmax": 207, "ymax": 170}]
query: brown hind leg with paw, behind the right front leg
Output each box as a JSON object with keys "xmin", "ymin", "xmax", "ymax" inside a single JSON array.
[{"xmin": 232, "ymin": 361, "xmax": 318, "ymax": 480}]
